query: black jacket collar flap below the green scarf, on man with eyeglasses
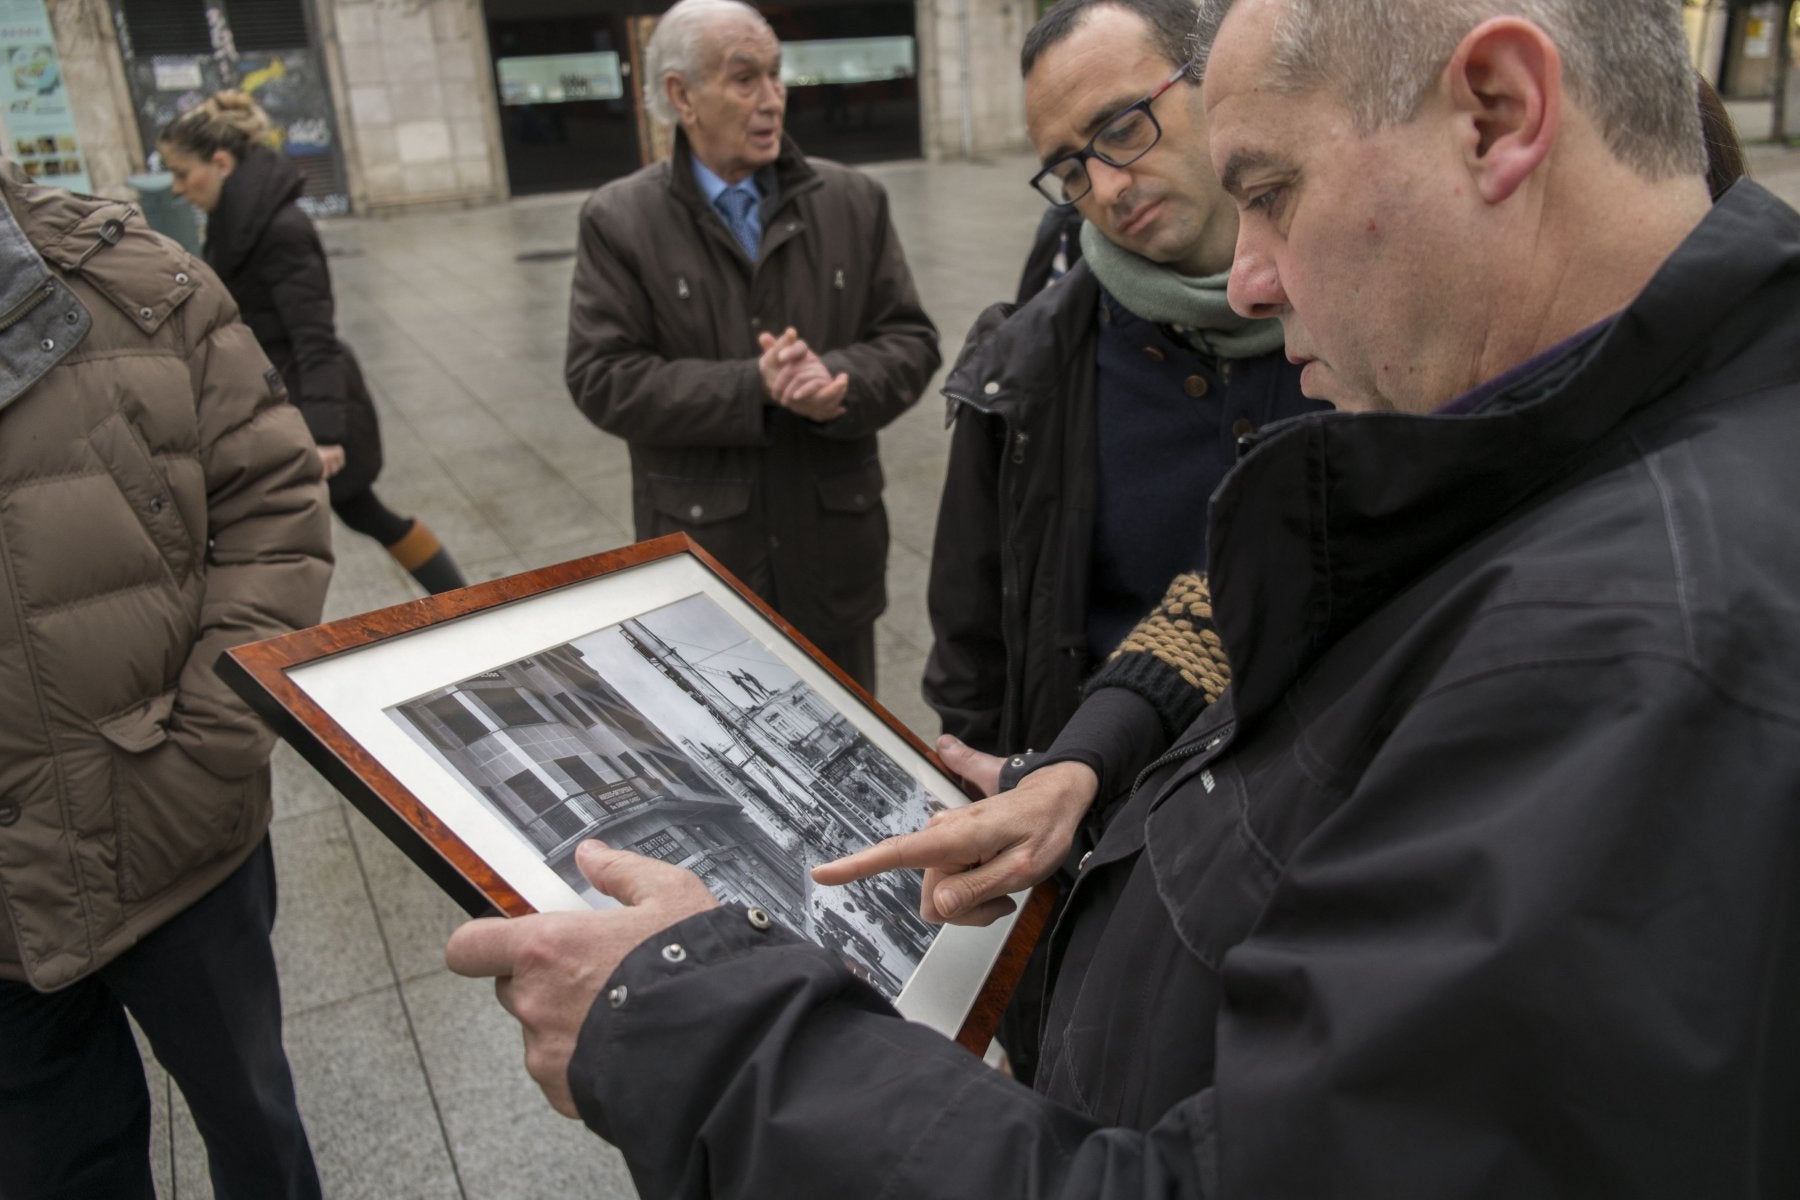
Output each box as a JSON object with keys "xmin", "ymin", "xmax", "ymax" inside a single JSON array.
[{"xmin": 943, "ymin": 259, "xmax": 1100, "ymax": 425}]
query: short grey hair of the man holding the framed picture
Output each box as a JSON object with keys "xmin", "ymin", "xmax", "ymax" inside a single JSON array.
[{"xmin": 1195, "ymin": 0, "xmax": 1706, "ymax": 180}]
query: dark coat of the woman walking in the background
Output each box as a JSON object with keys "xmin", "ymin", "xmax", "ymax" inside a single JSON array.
[{"xmin": 205, "ymin": 146, "xmax": 382, "ymax": 497}]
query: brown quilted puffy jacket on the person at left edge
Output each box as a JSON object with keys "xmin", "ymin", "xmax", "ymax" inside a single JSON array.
[{"xmin": 0, "ymin": 164, "xmax": 331, "ymax": 990}]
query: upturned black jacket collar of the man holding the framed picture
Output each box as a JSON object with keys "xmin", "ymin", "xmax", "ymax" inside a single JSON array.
[{"xmin": 1210, "ymin": 180, "xmax": 1800, "ymax": 716}]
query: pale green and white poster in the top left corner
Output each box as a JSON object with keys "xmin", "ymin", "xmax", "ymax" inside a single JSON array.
[{"xmin": 0, "ymin": 0, "xmax": 94, "ymax": 193}]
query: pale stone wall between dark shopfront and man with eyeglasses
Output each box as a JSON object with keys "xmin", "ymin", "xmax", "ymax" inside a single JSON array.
[{"xmin": 918, "ymin": 0, "xmax": 1037, "ymax": 158}]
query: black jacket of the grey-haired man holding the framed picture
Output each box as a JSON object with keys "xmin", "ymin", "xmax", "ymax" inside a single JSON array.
[{"xmin": 569, "ymin": 182, "xmax": 1800, "ymax": 1200}]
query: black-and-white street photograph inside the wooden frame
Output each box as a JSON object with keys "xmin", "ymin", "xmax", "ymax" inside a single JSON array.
[{"xmin": 387, "ymin": 594, "xmax": 938, "ymax": 999}]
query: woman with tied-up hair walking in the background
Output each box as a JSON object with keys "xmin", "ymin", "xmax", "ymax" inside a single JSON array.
[{"xmin": 158, "ymin": 92, "xmax": 463, "ymax": 592}]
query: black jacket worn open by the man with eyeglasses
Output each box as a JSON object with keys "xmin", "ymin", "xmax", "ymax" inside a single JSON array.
[{"xmin": 923, "ymin": 263, "xmax": 1319, "ymax": 754}]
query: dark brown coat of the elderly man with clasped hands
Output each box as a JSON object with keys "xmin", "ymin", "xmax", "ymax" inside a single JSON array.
[{"xmin": 565, "ymin": 135, "xmax": 938, "ymax": 637}]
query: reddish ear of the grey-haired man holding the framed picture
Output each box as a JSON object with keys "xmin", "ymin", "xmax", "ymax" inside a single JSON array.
[{"xmin": 1444, "ymin": 16, "xmax": 1562, "ymax": 203}]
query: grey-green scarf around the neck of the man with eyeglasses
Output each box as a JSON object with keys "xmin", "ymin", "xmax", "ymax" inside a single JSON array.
[{"xmin": 1082, "ymin": 221, "xmax": 1282, "ymax": 358}]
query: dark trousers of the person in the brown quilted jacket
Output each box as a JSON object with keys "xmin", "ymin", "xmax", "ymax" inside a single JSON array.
[{"xmin": 0, "ymin": 838, "xmax": 319, "ymax": 1200}]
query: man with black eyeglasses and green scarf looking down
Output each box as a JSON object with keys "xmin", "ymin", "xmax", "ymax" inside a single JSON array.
[{"xmin": 925, "ymin": 0, "xmax": 1321, "ymax": 877}]
